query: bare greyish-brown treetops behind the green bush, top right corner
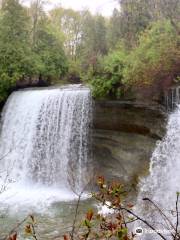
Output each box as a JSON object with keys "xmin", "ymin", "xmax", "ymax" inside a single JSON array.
[{"xmin": 119, "ymin": 0, "xmax": 180, "ymax": 47}]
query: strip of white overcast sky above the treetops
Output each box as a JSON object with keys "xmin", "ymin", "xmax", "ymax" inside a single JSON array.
[{"xmin": 24, "ymin": 0, "xmax": 119, "ymax": 16}]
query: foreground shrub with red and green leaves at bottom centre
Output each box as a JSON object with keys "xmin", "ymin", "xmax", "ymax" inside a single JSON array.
[{"xmin": 64, "ymin": 176, "xmax": 133, "ymax": 240}]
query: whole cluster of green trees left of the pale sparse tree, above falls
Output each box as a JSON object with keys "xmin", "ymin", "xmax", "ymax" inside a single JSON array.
[{"xmin": 0, "ymin": 0, "xmax": 67, "ymax": 101}]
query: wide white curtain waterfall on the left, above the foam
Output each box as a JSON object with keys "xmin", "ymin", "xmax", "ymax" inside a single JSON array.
[{"xmin": 0, "ymin": 85, "xmax": 92, "ymax": 206}]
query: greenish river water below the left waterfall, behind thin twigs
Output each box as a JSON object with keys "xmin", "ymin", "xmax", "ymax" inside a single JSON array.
[{"xmin": 0, "ymin": 199, "xmax": 97, "ymax": 240}]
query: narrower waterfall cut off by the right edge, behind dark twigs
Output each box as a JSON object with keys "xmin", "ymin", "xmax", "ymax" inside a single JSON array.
[{"xmin": 135, "ymin": 105, "xmax": 180, "ymax": 240}]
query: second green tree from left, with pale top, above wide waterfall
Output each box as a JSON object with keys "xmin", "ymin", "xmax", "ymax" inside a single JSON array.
[{"xmin": 30, "ymin": 0, "xmax": 67, "ymax": 84}]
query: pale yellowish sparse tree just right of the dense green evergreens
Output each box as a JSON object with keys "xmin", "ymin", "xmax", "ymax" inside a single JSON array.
[{"xmin": 50, "ymin": 8, "xmax": 84, "ymax": 83}]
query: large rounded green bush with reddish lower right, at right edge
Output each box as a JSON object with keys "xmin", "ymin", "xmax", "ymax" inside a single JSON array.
[{"xmin": 123, "ymin": 21, "xmax": 180, "ymax": 88}]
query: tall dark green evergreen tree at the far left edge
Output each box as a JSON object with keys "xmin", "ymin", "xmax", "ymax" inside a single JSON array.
[{"xmin": 0, "ymin": 0, "xmax": 32, "ymax": 100}]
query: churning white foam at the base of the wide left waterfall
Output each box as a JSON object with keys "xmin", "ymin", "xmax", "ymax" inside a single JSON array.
[{"xmin": 0, "ymin": 184, "xmax": 77, "ymax": 211}]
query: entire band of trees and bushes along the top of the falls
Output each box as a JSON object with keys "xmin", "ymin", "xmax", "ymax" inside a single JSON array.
[{"xmin": 0, "ymin": 0, "xmax": 180, "ymax": 101}]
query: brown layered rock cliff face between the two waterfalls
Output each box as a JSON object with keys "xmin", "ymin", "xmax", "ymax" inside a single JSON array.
[{"xmin": 93, "ymin": 101, "xmax": 166, "ymax": 181}]
